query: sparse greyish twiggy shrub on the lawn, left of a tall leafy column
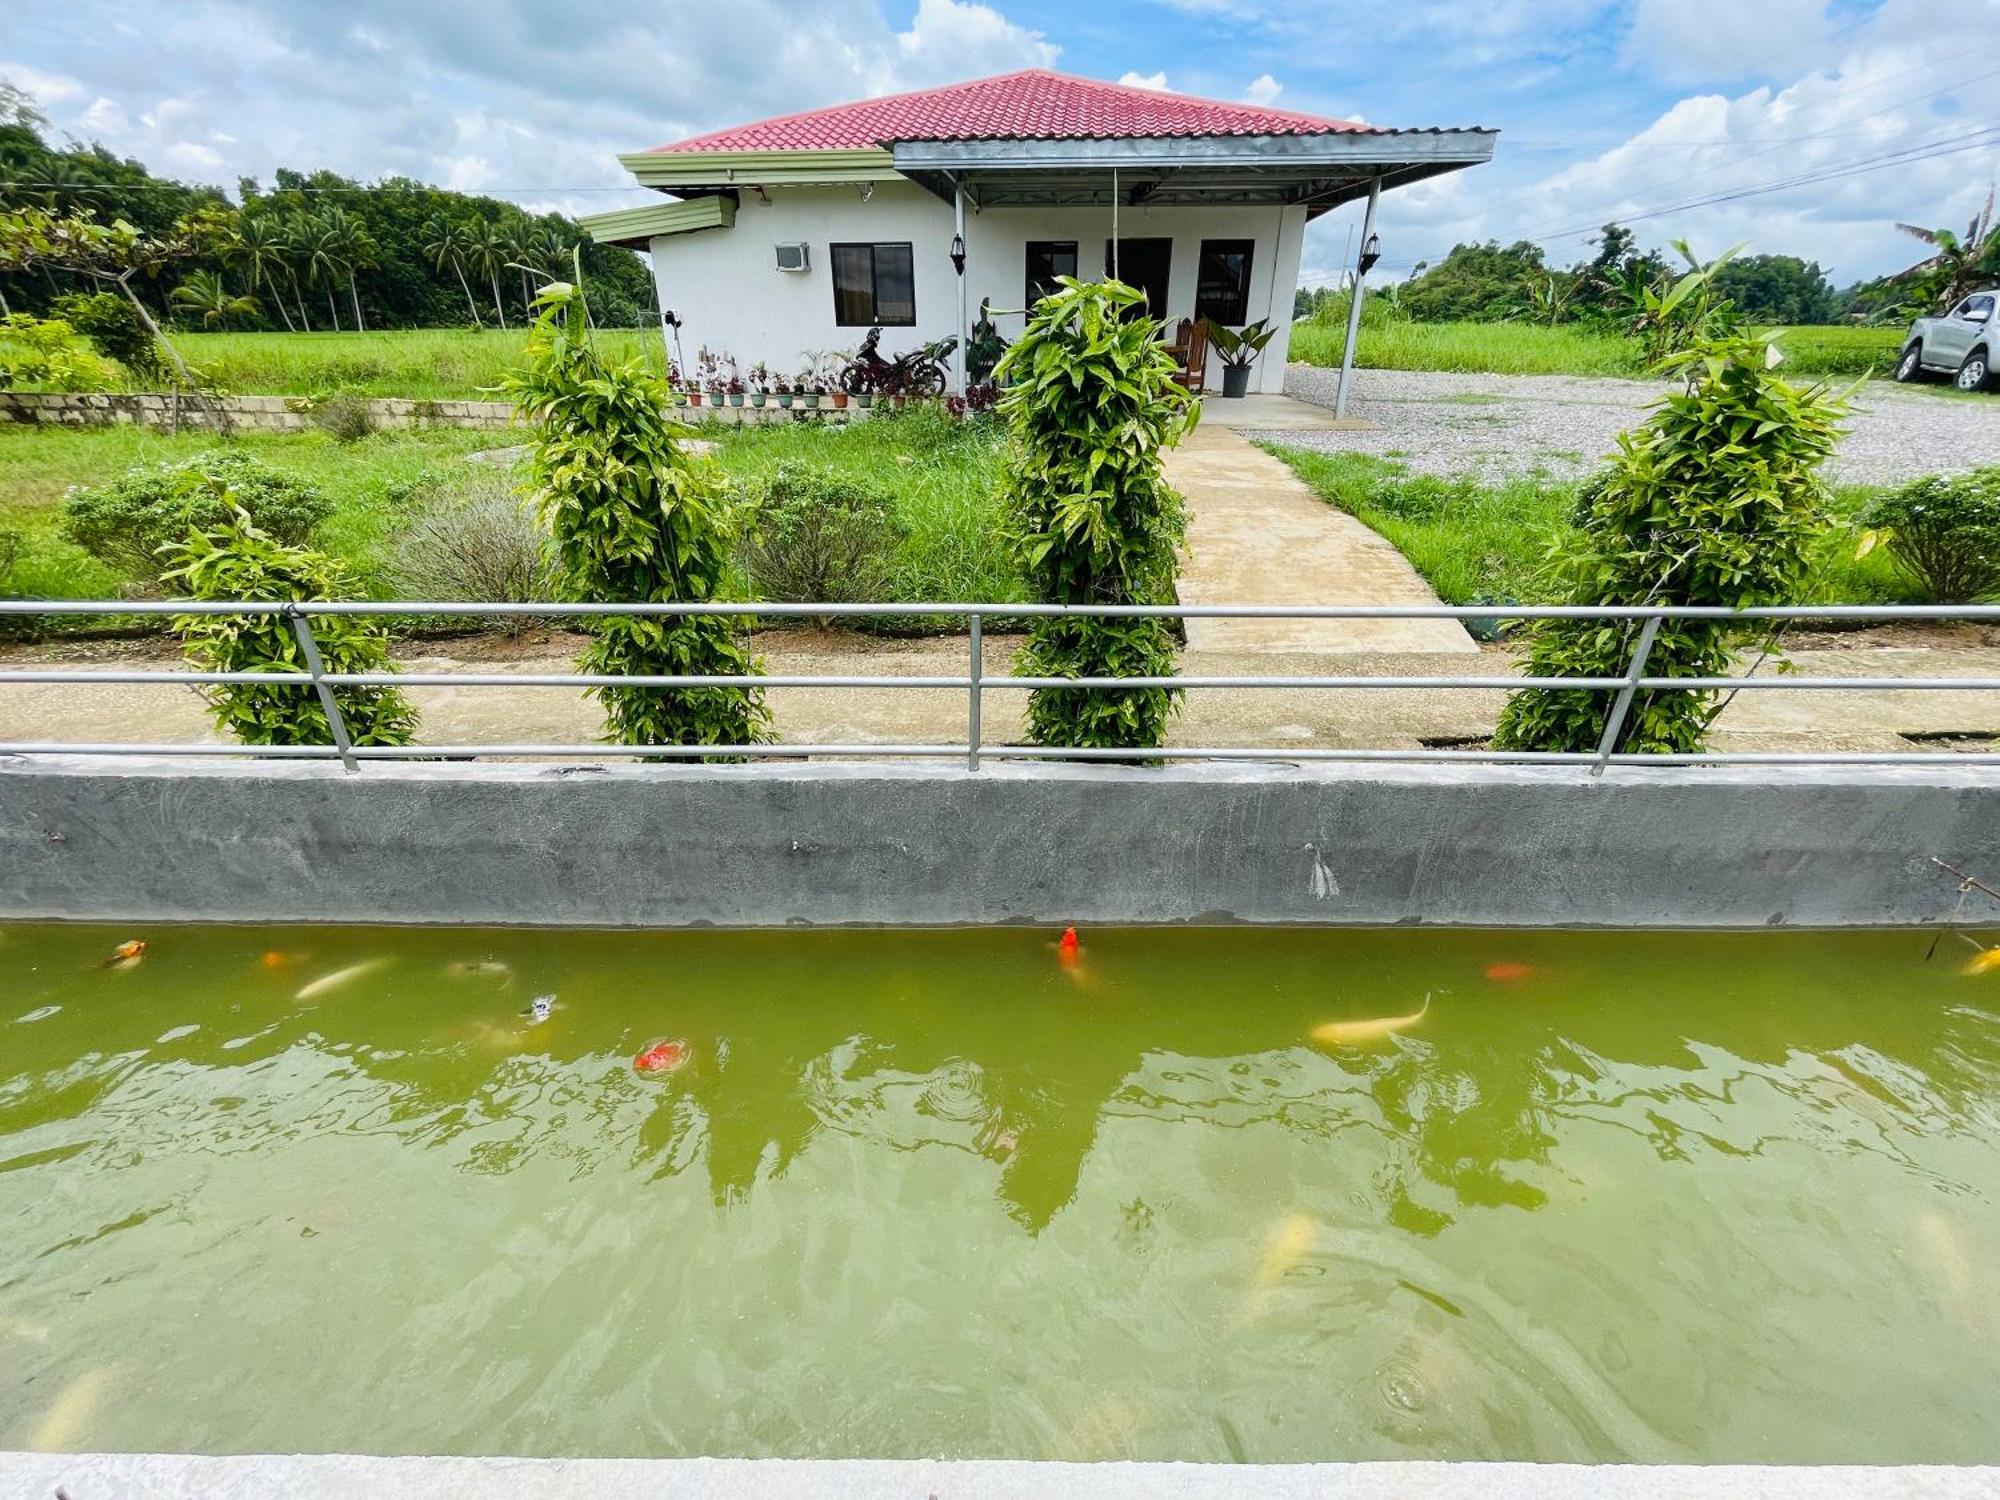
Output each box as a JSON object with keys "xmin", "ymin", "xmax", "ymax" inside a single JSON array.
[{"xmin": 388, "ymin": 474, "xmax": 560, "ymax": 624}]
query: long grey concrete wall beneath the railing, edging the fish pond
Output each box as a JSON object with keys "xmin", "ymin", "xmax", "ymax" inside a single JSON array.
[{"xmin": 0, "ymin": 758, "xmax": 2000, "ymax": 928}]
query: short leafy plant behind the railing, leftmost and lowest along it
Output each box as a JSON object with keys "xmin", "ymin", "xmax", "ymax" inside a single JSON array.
[{"xmin": 162, "ymin": 496, "xmax": 416, "ymax": 744}]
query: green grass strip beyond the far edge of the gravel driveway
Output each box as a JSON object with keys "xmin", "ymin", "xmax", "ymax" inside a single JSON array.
[{"xmin": 1292, "ymin": 318, "xmax": 1902, "ymax": 378}]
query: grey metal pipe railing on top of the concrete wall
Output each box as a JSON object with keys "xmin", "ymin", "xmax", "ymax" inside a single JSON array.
[{"xmin": 0, "ymin": 600, "xmax": 2000, "ymax": 776}]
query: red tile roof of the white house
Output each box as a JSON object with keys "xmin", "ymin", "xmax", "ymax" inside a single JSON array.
[{"xmin": 654, "ymin": 68, "xmax": 1372, "ymax": 152}]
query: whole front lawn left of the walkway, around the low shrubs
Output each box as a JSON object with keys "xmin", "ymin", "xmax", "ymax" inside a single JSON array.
[{"xmin": 0, "ymin": 408, "xmax": 1022, "ymax": 624}]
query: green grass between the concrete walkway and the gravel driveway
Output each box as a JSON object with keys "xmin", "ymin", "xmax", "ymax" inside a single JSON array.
[{"xmin": 1264, "ymin": 444, "xmax": 1922, "ymax": 604}]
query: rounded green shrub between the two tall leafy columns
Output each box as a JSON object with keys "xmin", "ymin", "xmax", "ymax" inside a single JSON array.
[{"xmin": 744, "ymin": 462, "xmax": 910, "ymax": 604}]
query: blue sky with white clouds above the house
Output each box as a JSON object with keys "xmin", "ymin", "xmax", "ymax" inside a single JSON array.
[{"xmin": 0, "ymin": 0, "xmax": 2000, "ymax": 284}]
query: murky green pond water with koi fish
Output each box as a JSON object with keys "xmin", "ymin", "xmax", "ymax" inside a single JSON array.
[{"xmin": 0, "ymin": 926, "xmax": 2000, "ymax": 1462}]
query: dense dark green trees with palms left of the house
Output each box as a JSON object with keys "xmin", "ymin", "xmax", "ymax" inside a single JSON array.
[{"xmin": 0, "ymin": 82, "xmax": 654, "ymax": 332}]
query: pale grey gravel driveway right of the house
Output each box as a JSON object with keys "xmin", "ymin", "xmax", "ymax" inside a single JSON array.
[{"xmin": 1246, "ymin": 364, "xmax": 2000, "ymax": 484}]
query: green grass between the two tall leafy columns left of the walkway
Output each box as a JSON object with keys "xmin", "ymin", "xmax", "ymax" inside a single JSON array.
[{"xmin": 714, "ymin": 408, "xmax": 1026, "ymax": 602}]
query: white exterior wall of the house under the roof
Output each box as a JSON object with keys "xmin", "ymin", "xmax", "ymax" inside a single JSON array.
[{"xmin": 652, "ymin": 182, "xmax": 1306, "ymax": 392}]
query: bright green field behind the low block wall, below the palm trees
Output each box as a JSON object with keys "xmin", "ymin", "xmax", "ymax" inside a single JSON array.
[{"xmin": 146, "ymin": 328, "xmax": 662, "ymax": 400}]
